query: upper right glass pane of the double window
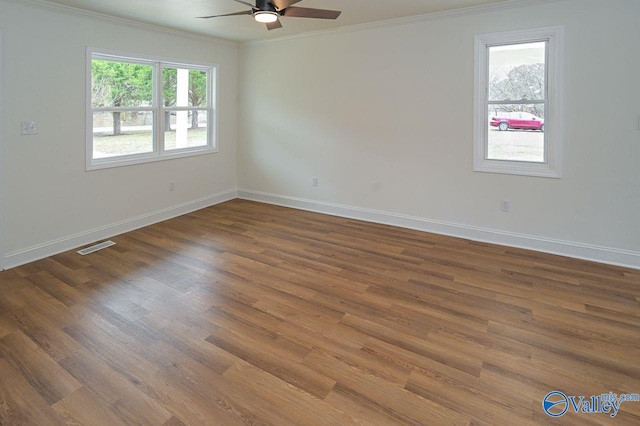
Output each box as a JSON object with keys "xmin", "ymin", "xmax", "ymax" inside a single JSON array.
[{"xmin": 162, "ymin": 68, "xmax": 207, "ymax": 107}]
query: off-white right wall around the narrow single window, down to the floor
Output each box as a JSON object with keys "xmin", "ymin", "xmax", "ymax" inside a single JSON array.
[{"xmin": 238, "ymin": 0, "xmax": 640, "ymax": 268}]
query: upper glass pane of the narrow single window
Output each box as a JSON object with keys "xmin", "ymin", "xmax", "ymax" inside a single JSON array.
[{"xmin": 489, "ymin": 42, "xmax": 546, "ymax": 101}]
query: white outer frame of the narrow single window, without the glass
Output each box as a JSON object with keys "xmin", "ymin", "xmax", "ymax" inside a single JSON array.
[{"xmin": 473, "ymin": 26, "xmax": 564, "ymax": 178}]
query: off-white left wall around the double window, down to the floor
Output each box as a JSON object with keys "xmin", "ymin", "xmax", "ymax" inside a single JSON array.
[{"xmin": 0, "ymin": 0, "xmax": 238, "ymax": 267}]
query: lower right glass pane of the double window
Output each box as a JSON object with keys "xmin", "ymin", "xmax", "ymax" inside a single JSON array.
[{"xmin": 164, "ymin": 110, "xmax": 207, "ymax": 151}]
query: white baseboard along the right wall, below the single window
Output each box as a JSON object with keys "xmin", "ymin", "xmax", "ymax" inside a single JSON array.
[{"xmin": 238, "ymin": 189, "xmax": 640, "ymax": 269}]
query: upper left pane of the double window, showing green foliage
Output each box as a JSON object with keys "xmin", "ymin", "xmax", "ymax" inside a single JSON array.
[{"xmin": 91, "ymin": 59, "xmax": 153, "ymax": 108}]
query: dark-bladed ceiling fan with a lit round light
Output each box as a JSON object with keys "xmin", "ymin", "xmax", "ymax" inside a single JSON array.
[{"xmin": 198, "ymin": 0, "xmax": 342, "ymax": 30}]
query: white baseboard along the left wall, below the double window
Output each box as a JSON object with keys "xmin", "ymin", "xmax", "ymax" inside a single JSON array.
[{"xmin": 2, "ymin": 189, "xmax": 237, "ymax": 269}]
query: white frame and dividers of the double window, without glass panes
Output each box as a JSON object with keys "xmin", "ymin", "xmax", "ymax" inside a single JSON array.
[{"xmin": 85, "ymin": 47, "xmax": 219, "ymax": 171}]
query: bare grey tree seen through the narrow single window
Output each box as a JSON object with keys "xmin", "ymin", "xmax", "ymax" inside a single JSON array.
[{"xmin": 489, "ymin": 64, "xmax": 545, "ymax": 118}]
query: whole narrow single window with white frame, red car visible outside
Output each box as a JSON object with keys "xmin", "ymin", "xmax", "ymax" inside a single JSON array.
[{"xmin": 474, "ymin": 27, "xmax": 562, "ymax": 178}]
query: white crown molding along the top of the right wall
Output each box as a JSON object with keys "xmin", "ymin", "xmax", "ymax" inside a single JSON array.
[{"xmin": 244, "ymin": 0, "xmax": 565, "ymax": 46}]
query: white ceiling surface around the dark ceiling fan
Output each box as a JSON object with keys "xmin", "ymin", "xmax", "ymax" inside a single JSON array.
[{"xmin": 31, "ymin": 0, "xmax": 518, "ymax": 42}]
